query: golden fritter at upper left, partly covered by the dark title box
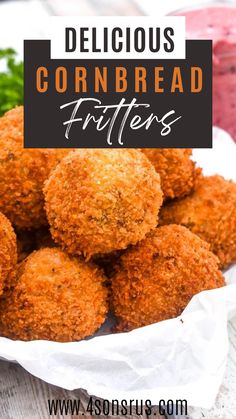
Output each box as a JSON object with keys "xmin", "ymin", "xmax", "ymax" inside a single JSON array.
[{"xmin": 0, "ymin": 106, "xmax": 68, "ymax": 229}]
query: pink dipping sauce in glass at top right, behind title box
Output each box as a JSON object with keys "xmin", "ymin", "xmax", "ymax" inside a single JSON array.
[{"xmin": 175, "ymin": 3, "xmax": 236, "ymax": 140}]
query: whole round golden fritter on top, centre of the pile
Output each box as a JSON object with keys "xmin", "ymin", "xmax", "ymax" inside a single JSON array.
[{"xmin": 44, "ymin": 149, "xmax": 162, "ymax": 259}]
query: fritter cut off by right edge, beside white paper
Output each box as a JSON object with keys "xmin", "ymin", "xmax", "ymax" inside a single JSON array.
[{"xmin": 160, "ymin": 176, "xmax": 236, "ymax": 267}]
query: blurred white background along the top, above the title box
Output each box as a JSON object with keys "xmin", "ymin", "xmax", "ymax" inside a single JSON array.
[{"xmin": 0, "ymin": 0, "xmax": 236, "ymax": 55}]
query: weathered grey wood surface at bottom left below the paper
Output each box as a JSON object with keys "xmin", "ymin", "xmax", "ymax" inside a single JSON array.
[{"xmin": 0, "ymin": 361, "xmax": 163, "ymax": 419}]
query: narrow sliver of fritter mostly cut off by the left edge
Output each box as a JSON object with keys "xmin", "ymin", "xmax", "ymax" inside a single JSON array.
[{"xmin": 0, "ymin": 212, "xmax": 17, "ymax": 295}]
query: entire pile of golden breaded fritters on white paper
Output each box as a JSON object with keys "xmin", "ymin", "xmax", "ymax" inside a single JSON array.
[{"xmin": 0, "ymin": 107, "xmax": 236, "ymax": 342}]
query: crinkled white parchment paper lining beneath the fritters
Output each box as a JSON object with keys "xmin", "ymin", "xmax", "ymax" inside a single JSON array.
[{"xmin": 0, "ymin": 129, "xmax": 236, "ymax": 408}]
